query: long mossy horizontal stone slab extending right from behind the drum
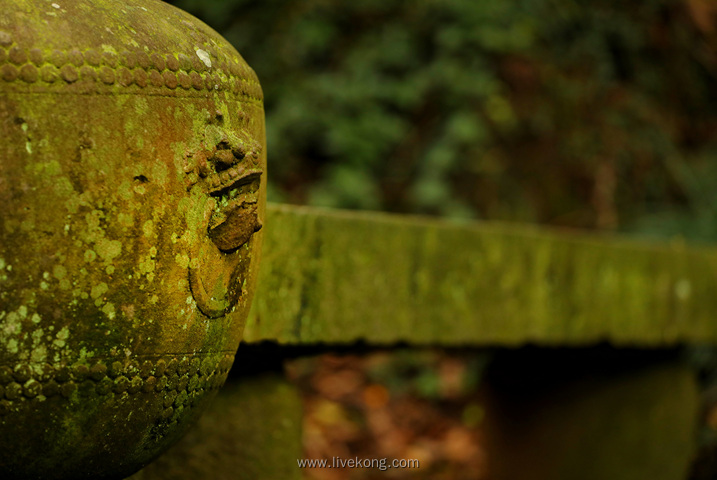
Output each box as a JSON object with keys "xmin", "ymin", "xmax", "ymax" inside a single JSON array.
[{"xmin": 245, "ymin": 205, "xmax": 717, "ymax": 346}]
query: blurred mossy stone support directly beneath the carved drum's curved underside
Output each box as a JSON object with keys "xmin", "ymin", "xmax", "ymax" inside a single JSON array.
[{"xmin": 130, "ymin": 375, "xmax": 302, "ymax": 480}]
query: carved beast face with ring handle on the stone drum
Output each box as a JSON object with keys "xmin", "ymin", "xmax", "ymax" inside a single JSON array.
[{"xmin": 185, "ymin": 112, "xmax": 263, "ymax": 318}]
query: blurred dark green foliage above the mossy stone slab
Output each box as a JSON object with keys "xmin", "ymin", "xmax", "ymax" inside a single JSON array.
[{"xmin": 172, "ymin": 0, "xmax": 717, "ymax": 241}]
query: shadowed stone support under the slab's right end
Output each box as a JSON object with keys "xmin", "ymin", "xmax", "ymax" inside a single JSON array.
[{"xmin": 478, "ymin": 349, "xmax": 699, "ymax": 480}]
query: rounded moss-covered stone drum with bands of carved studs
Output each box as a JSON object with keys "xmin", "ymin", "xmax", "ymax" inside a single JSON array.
[{"xmin": 0, "ymin": 0, "xmax": 266, "ymax": 479}]
